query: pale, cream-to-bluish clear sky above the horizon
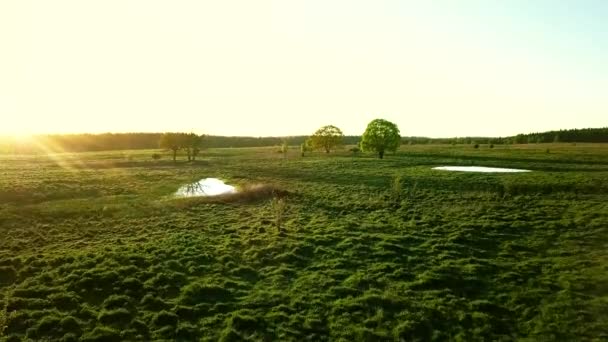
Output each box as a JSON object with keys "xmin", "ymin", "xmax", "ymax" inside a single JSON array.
[{"xmin": 0, "ymin": 0, "xmax": 608, "ymax": 137}]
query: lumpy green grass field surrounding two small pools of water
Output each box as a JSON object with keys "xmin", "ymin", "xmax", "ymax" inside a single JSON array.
[{"xmin": 0, "ymin": 144, "xmax": 608, "ymax": 341}]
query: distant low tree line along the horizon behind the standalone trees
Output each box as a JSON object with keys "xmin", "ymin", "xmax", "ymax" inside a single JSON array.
[{"xmin": 0, "ymin": 127, "xmax": 608, "ymax": 154}]
